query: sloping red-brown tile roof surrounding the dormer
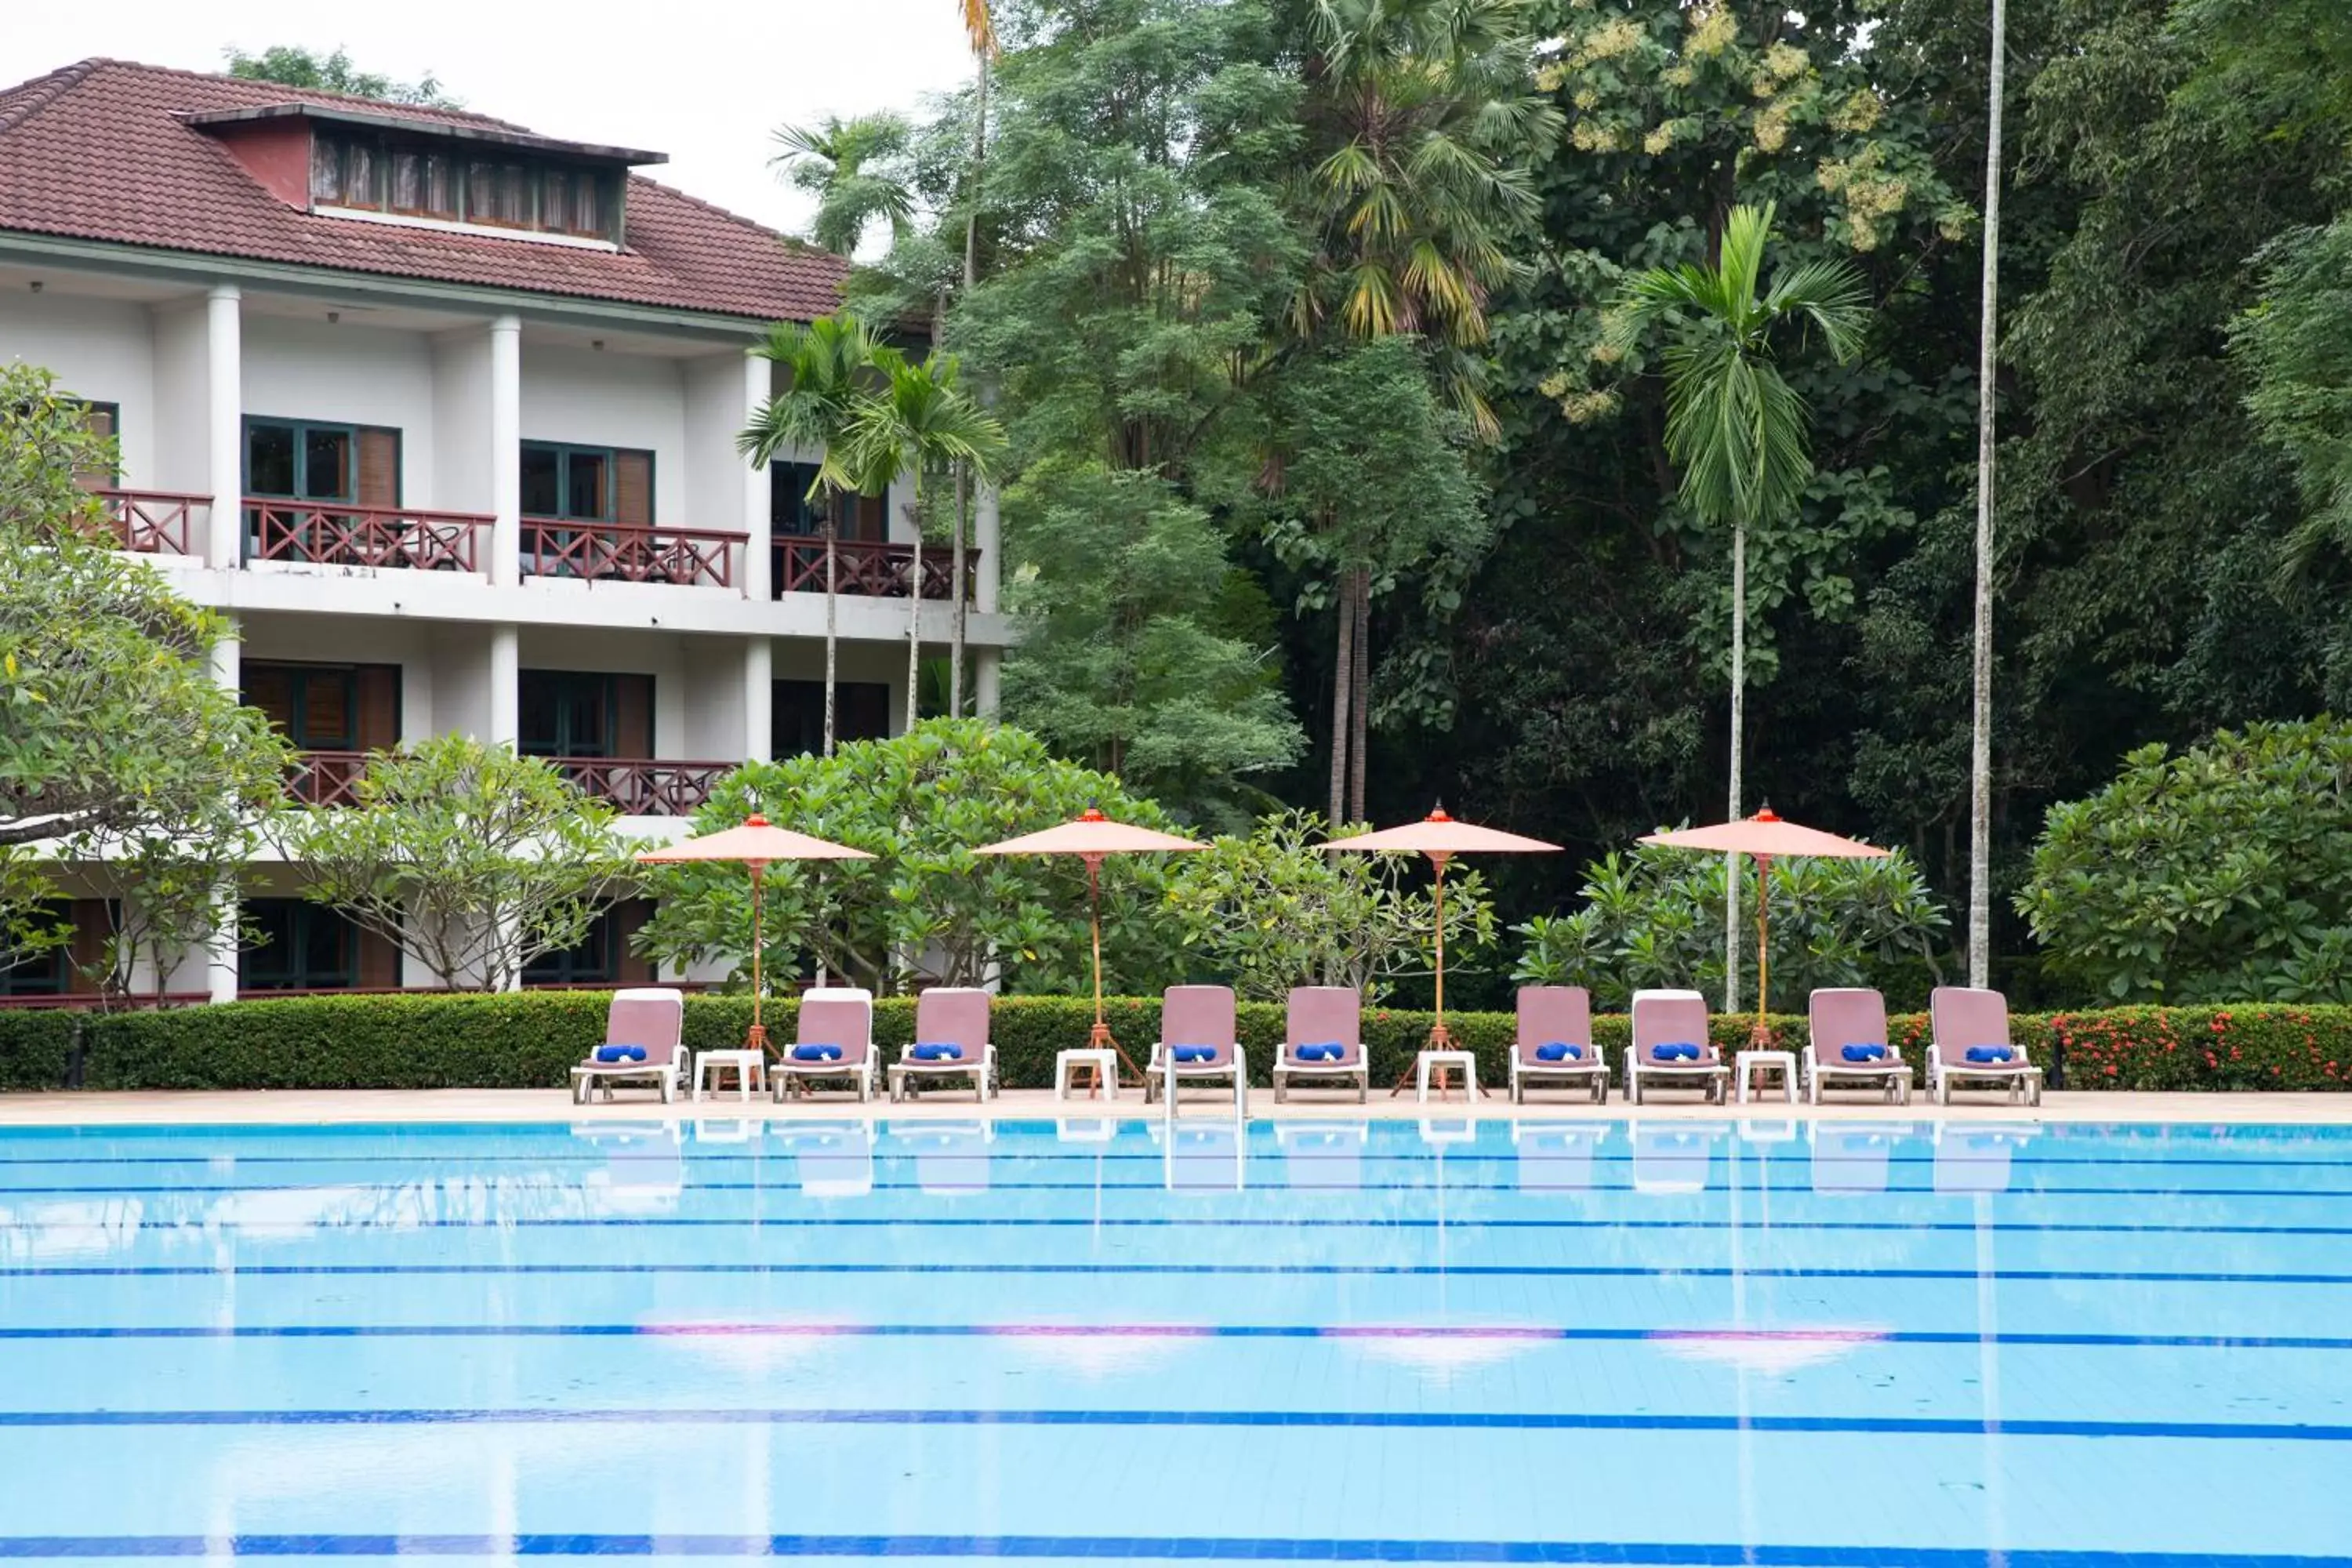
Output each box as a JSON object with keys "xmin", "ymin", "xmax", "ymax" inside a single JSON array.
[{"xmin": 0, "ymin": 59, "xmax": 847, "ymax": 320}]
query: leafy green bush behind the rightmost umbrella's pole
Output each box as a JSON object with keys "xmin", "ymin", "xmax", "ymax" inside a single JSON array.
[{"xmin": 1512, "ymin": 844, "xmax": 1947, "ymax": 1006}]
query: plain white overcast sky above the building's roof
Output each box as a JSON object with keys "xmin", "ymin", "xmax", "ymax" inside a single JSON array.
[{"xmin": 0, "ymin": 0, "xmax": 971, "ymax": 230}]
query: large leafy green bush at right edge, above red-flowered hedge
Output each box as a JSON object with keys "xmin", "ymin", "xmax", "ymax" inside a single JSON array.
[{"xmin": 2018, "ymin": 720, "xmax": 2352, "ymax": 1001}]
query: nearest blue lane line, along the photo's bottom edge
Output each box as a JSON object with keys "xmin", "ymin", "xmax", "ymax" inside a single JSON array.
[{"xmin": 0, "ymin": 1533, "xmax": 2352, "ymax": 1568}]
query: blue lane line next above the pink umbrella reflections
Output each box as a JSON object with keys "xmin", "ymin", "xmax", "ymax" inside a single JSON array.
[{"xmin": 0, "ymin": 1262, "xmax": 2352, "ymax": 1279}]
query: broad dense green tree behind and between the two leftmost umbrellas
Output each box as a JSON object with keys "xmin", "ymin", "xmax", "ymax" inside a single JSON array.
[{"xmin": 637, "ymin": 720, "xmax": 1174, "ymax": 992}]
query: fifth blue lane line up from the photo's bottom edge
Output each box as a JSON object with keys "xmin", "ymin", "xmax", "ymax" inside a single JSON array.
[{"xmin": 18, "ymin": 1213, "xmax": 2352, "ymax": 1241}]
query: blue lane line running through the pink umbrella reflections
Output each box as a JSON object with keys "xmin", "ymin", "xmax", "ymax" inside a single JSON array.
[{"xmin": 0, "ymin": 1319, "xmax": 2352, "ymax": 1352}]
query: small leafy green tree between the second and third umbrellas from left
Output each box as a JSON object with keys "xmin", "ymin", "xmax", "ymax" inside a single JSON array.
[{"xmin": 1167, "ymin": 811, "xmax": 1494, "ymax": 1001}]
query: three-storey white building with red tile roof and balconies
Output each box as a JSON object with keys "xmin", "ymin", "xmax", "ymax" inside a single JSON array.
[{"xmin": 0, "ymin": 61, "xmax": 1007, "ymax": 996}]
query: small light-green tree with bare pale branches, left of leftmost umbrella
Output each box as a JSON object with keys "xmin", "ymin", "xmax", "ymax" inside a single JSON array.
[{"xmin": 282, "ymin": 736, "xmax": 637, "ymax": 992}]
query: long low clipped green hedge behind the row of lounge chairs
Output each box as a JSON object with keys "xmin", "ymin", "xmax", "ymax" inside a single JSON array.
[{"xmin": 0, "ymin": 992, "xmax": 2352, "ymax": 1088}]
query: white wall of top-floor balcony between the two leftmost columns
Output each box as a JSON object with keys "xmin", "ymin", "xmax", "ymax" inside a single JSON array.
[{"xmin": 245, "ymin": 310, "xmax": 435, "ymax": 506}]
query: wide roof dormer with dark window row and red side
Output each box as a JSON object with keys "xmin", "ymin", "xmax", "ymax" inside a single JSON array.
[{"xmin": 188, "ymin": 101, "xmax": 668, "ymax": 249}]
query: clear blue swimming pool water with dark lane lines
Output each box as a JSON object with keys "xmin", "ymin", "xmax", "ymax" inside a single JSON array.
[{"xmin": 0, "ymin": 1116, "xmax": 2352, "ymax": 1568}]
